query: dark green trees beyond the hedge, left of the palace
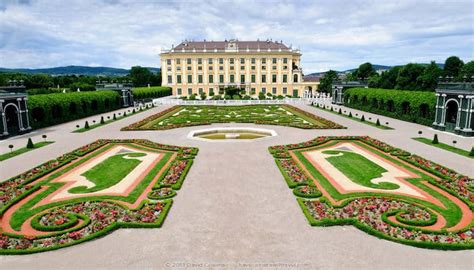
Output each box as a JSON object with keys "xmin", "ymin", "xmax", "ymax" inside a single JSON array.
[{"xmin": 0, "ymin": 66, "xmax": 161, "ymax": 95}]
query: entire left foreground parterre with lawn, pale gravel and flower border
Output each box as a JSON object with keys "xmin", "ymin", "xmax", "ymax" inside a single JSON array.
[{"xmin": 0, "ymin": 140, "xmax": 198, "ymax": 254}]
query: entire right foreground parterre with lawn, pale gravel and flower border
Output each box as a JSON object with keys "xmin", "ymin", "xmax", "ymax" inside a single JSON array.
[{"xmin": 269, "ymin": 136, "xmax": 474, "ymax": 249}]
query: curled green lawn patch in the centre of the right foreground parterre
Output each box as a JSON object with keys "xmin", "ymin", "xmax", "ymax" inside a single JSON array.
[{"xmin": 323, "ymin": 150, "xmax": 399, "ymax": 189}]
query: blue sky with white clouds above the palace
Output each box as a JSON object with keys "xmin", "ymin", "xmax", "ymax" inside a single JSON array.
[{"xmin": 0, "ymin": 0, "xmax": 474, "ymax": 73}]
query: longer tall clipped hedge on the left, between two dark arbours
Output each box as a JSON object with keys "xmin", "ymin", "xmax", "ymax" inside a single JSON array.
[{"xmin": 28, "ymin": 91, "xmax": 121, "ymax": 128}]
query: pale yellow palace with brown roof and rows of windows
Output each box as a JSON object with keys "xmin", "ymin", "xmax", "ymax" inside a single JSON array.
[{"xmin": 160, "ymin": 40, "xmax": 319, "ymax": 97}]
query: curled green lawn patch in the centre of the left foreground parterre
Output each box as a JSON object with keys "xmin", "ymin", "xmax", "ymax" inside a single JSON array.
[{"xmin": 69, "ymin": 153, "xmax": 146, "ymax": 193}]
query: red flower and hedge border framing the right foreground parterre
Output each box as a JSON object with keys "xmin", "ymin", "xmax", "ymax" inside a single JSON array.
[{"xmin": 269, "ymin": 136, "xmax": 474, "ymax": 249}]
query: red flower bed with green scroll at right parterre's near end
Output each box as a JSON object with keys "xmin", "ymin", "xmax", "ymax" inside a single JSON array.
[{"xmin": 301, "ymin": 198, "xmax": 474, "ymax": 249}]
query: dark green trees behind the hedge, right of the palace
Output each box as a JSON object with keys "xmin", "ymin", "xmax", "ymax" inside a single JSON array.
[{"xmin": 319, "ymin": 56, "xmax": 474, "ymax": 92}]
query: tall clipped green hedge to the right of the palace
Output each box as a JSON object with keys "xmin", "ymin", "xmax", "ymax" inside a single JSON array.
[{"xmin": 344, "ymin": 88, "xmax": 436, "ymax": 126}]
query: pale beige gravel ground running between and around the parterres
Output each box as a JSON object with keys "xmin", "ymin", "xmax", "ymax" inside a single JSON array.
[{"xmin": 0, "ymin": 105, "xmax": 474, "ymax": 269}]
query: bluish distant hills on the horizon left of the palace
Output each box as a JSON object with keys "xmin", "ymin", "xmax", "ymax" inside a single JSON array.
[{"xmin": 0, "ymin": 66, "xmax": 160, "ymax": 76}]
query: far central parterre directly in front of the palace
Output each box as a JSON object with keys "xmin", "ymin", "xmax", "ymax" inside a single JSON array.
[{"xmin": 122, "ymin": 105, "xmax": 344, "ymax": 130}]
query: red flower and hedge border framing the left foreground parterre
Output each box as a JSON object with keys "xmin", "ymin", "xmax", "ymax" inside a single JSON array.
[{"xmin": 0, "ymin": 139, "xmax": 198, "ymax": 254}]
